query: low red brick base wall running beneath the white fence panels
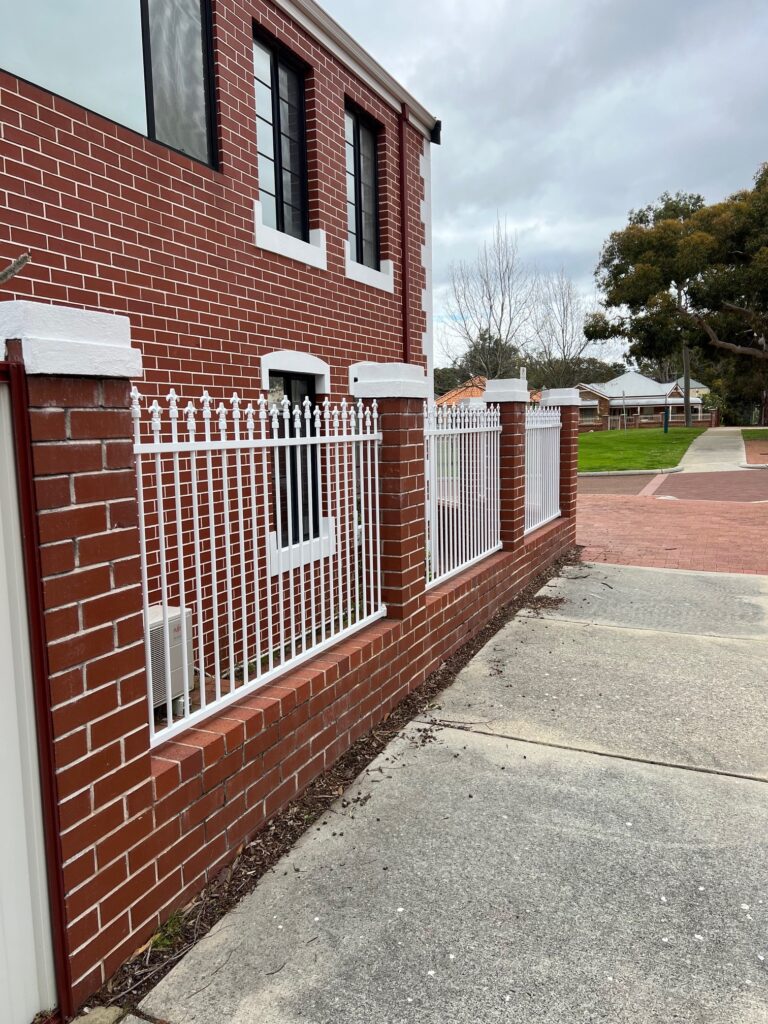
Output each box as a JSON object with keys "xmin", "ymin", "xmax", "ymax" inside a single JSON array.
[{"xmin": 75, "ymin": 520, "xmax": 574, "ymax": 1002}]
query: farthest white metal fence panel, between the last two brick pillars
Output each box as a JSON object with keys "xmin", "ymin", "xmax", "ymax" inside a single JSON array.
[{"xmin": 525, "ymin": 407, "xmax": 560, "ymax": 534}]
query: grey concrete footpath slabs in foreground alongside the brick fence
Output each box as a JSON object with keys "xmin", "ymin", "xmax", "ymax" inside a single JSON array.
[{"xmin": 140, "ymin": 565, "xmax": 768, "ymax": 1024}]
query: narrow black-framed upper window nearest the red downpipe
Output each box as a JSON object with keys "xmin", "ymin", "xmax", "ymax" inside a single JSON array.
[{"xmin": 344, "ymin": 106, "xmax": 379, "ymax": 270}]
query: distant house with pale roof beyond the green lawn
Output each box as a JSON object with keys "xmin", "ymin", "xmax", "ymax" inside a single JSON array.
[{"xmin": 577, "ymin": 370, "xmax": 707, "ymax": 424}]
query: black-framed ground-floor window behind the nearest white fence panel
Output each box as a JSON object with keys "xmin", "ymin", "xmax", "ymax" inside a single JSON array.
[{"xmin": 269, "ymin": 373, "xmax": 319, "ymax": 548}]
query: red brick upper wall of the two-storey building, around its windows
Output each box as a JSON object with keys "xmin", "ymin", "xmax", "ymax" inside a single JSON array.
[{"xmin": 0, "ymin": 0, "xmax": 426, "ymax": 398}]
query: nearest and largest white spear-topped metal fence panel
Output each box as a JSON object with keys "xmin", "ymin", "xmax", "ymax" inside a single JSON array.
[{"xmin": 132, "ymin": 388, "xmax": 386, "ymax": 742}]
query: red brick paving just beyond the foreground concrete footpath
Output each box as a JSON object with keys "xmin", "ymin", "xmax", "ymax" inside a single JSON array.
[{"xmin": 577, "ymin": 495, "xmax": 768, "ymax": 574}]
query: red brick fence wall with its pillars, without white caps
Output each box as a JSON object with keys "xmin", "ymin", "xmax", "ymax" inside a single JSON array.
[{"xmin": 29, "ymin": 368, "xmax": 575, "ymax": 1005}]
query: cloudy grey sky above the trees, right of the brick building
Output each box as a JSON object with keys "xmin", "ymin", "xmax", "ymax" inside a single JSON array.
[{"xmin": 321, "ymin": 0, "xmax": 768, "ymax": 360}]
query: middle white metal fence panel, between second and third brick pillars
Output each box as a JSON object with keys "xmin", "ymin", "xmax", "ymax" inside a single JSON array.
[{"xmin": 424, "ymin": 403, "xmax": 501, "ymax": 587}]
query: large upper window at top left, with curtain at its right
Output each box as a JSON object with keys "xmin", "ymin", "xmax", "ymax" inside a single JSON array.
[{"xmin": 0, "ymin": 0, "xmax": 214, "ymax": 164}]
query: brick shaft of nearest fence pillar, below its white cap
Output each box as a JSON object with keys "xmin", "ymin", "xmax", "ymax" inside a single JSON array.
[{"xmin": 29, "ymin": 378, "xmax": 157, "ymax": 1001}]
